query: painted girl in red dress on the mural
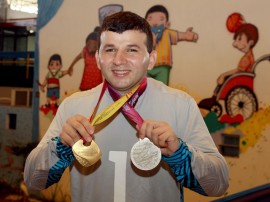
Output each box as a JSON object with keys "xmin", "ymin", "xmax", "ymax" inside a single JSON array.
[{"xmin": 69, "ymin": 27, "xmax": 103, "ymax": 91}]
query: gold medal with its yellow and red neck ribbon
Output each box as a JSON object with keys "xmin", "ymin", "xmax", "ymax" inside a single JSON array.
[{"xmin": 72, "ymin": 81, "xmax": 140, "ymax": 167}]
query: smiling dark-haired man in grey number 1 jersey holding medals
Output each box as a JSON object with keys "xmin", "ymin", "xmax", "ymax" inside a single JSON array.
[{"xmin": 25, "ymin": 12, "xmax": 228, "ymax": 202}]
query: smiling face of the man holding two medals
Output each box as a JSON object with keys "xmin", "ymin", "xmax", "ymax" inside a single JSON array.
[{"xmin": 96, "ymin": 30, "xmax": 156, "ymax": 94}]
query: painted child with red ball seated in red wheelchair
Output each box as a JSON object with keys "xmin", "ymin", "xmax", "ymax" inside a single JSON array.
[{"xmin": 198, "ymin": 13, "xmax": 267, "ymax": 123}]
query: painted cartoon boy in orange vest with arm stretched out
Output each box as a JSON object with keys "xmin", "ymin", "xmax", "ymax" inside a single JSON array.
[{"xmin": 145, "ymin": 5, "xmax": 198, "ymax": 85}]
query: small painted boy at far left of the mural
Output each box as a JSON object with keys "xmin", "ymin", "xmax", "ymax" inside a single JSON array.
[{"xmin": 40, "ymin": 54, "xmax": 70, "ymax": 108}]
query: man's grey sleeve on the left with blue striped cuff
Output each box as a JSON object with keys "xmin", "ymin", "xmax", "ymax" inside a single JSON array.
[{"xmin": 24, "ymin": 99, "xmax": 74, "ymax": 190}]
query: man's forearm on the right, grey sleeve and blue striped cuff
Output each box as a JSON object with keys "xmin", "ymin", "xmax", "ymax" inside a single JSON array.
[{"xmin": 162, "ymin": 140, "xmax": 228, "ymax": 196}]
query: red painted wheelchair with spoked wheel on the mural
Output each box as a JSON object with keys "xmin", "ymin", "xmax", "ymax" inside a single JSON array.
[{"xmin": 198, "ymin": 54, "xmax": 270, "ymax": 119}]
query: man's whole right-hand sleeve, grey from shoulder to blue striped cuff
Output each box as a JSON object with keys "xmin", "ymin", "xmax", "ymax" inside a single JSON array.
[{"xmin": 163, "ymin": 94, "xmax": 229, "ymax": 196}]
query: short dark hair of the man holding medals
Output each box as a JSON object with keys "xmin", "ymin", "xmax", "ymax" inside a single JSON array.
[{"xmin": 98, "ymin": 11, "xmax": 153, "ymax": 53}]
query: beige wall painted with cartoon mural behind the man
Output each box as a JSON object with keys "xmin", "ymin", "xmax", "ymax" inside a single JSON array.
[{"xmin": 35, "ymin": 0, "xmax": 270, "ymax": 201}]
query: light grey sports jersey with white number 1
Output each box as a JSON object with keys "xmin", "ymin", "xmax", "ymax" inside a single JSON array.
[{"xmin": 25, "ymin": 78, "xmax": 228, "ymax": 202}]
